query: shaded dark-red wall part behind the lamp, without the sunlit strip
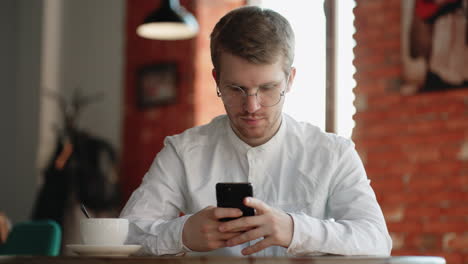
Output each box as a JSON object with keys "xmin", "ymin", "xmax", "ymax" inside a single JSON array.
[{"xmin": 122, "ymin": 0, "xmax": 196, "ymax": 201}]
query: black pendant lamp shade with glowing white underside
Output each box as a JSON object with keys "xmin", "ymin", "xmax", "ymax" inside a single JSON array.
[{"xmin": 137, "ymin": 0, "xmax": 198, "ymax": 40}]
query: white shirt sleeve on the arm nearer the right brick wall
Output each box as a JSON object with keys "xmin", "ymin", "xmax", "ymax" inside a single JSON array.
[{"xmin": 287, "ymin": 144, "xmax": 392, "ymax": 256}]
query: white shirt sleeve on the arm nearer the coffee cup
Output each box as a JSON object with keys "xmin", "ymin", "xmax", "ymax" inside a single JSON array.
[{"xmin": 120, "ymin": 138, "xmax": 190, "ymax": 256}]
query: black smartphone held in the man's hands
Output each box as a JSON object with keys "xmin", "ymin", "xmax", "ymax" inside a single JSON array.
[{"xmin": 216, "ymin": 182, "xmax": 255, "ymax": 222}]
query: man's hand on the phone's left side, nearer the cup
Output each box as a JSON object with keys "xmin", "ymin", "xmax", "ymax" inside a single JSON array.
[{"xmin": 182, "ymin": 206, "xmax": 242, "ymax": 251}]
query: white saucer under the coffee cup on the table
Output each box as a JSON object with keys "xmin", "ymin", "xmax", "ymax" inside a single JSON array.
[{"xmin": 67, "ymin": 244, "xmax": 141, "ymax": 257}]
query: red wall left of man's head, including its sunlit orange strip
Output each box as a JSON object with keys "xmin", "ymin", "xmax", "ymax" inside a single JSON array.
[{"xmin": 122, "ymin": 0, "xmax": 245, "ymax": 201}]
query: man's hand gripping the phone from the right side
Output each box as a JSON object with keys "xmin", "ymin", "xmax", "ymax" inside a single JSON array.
[{"xmin": 219, "ymin": 197, "xmax": 294, "ymax": 255}]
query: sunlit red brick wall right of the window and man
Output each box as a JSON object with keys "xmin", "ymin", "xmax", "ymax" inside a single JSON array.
[{"xmin": 353, "ymin": 0, "xmax": 468, "ymax": 264}]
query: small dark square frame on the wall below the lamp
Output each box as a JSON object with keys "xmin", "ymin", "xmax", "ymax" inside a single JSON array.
[{"xmin": 137, "ymin": 63, "xmax": 177, "ymax": 108}]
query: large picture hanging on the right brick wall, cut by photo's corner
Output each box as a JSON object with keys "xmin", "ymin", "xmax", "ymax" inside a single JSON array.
[{"xmin": 401, "ymin": 0, "xmax": 468, "ymax": 94}]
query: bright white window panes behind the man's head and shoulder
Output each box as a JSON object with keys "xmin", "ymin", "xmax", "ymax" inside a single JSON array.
[{"xmin": 251, "ymin": 0, "xmax": 355, "ymax": 138}]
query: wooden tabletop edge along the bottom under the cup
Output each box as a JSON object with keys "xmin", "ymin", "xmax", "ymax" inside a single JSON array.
[{"xmin": 0, "ymin": 256, "xmax": 445, "ymax": 264}]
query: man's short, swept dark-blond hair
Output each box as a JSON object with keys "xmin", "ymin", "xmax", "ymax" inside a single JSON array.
[{"xmin": 210, "ymin": 6, "xmax": 294, "ymax": 75}]
